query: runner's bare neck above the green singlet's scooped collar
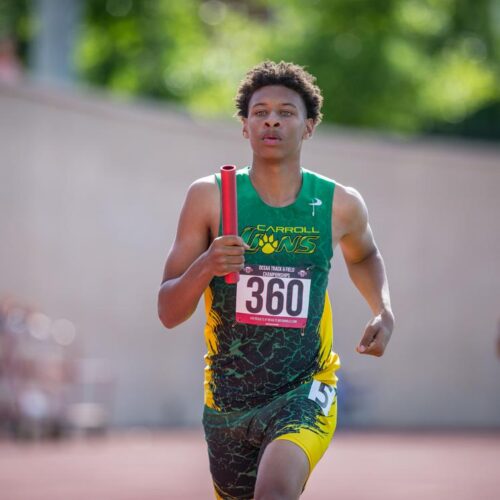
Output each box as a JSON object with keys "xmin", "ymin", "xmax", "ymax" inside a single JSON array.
[{"xmin": 250, "ymin": 161, "xmax": 302, "ymax": 207}]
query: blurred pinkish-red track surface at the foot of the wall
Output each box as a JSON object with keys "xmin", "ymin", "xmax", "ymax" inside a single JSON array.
[{"xmin": 0, "ymin": 431, "xmax": 500, "ymax": 500}]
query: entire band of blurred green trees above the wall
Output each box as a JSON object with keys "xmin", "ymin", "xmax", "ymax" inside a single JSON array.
[{"xmin": 2, "ymin": 0, "xmax": 500, "ymax": 140}]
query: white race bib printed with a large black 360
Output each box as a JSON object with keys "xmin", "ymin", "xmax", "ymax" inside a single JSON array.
[{"xmin": 236, "ymin": 264, "xmax": 311, "ymax": 328}]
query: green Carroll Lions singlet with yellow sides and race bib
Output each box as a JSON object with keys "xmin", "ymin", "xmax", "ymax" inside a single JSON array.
[{"xmin": 205, "ymin": 167, "xmax": 340, "ymax": 412}]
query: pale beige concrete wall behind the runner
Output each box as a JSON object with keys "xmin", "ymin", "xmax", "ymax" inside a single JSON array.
[{"xmin": 0, "ymin": 87, "xmax": 500, "ymax": 426}]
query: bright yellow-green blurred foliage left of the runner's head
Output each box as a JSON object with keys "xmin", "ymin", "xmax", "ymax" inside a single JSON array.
[{"xmin": 77, "ymin": 0, "xmax": 271, "ymax": 111}]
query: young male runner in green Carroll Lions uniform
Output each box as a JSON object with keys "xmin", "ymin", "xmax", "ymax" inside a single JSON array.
[{"xmin": 158, "ymin": 61, "xmax": 394, "ymax": 500}]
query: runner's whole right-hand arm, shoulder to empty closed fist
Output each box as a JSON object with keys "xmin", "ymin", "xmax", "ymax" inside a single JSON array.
[{"xmin": 333, "ymin": 185, "xmax": 394, "ymax": 356}]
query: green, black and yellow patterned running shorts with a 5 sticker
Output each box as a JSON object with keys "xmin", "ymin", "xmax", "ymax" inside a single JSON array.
[{"xmin": 203, "ymin": 381, "xmax": 337, "ymax": 500}]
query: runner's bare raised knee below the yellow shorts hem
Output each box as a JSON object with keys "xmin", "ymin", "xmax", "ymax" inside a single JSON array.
[{"xmin": 255, "ymin": 439, "xmax": 310, "ymax": 500}]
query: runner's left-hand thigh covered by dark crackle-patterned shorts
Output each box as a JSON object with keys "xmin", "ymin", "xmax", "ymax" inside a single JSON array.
[{"xmin": 203, "ymin": 408, "xmax": 259, "ymax": 500}]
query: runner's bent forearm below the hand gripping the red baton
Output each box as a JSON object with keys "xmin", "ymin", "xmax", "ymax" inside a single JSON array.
[{"xmin": 158, "ymin": 252, "xmax": 214, "ymax": 328}]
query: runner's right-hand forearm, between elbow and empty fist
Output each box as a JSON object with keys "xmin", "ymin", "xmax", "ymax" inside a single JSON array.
[{"xmin": 347, "ymin": 247, "xmax": 392, "ymax": 315}]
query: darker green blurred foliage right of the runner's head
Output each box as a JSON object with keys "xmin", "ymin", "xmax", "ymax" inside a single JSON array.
[{"xmin": 268, "ymin": 0, "xmax": 500, "ymax": 138}]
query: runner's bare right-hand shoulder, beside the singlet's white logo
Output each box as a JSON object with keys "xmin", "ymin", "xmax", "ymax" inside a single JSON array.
[{"xmin": 332, "ymin": 184, "xmax": 368, "ymax": 242}]
